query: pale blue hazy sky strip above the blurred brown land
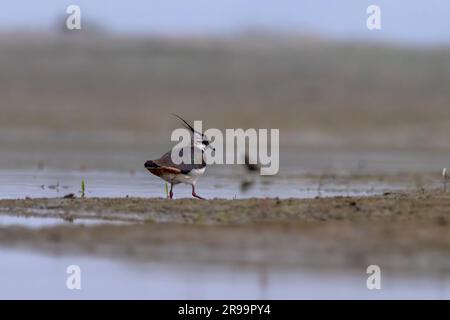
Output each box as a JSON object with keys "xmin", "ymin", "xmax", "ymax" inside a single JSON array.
[{"xmin": 0, "ymin": 0, "xmax": 450, "ymax": 43}]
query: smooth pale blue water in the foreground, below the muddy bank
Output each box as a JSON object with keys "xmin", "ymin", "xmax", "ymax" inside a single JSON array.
[{"xmin": 0, "ymin": 249, "xmax": 450, "ymax": 299}]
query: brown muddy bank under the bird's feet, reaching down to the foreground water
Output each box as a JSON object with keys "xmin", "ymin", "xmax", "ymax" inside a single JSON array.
[{"xmin": 0, "ymin": 192, "xmax": 450, "ymax": 273}]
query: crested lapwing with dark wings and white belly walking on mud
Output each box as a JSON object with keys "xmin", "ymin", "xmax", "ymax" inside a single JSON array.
[{"xmin": 145, "ymin": 114, "xmax": 215, "ymax": 200}]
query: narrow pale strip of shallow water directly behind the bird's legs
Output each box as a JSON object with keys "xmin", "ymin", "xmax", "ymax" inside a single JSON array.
[{"xmin": 0, "ymin": 169, "xmax": 402, "ymax": 199}]
